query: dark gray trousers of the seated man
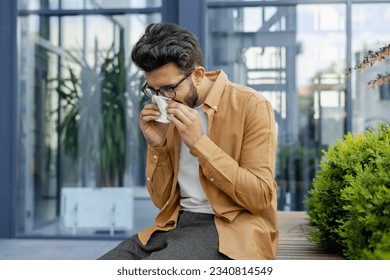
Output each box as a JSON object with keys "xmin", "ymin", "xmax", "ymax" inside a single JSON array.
[{"xmin": 99, "ymin": 211, "xmax": 230, "ymax": 260}]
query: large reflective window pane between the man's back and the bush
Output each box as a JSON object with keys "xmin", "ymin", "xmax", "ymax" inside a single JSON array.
[{"xmin": 207, "ymin": 3, "xmax": 346, "ymax": 210}]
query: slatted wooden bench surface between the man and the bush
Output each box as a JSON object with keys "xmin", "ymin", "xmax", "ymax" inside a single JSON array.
[{"xmin": 276, "ymin": 211, "xmax": 343, "ymax": 260}]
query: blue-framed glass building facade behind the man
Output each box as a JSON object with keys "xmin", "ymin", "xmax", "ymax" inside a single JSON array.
[{"xmin": 0, "ymin": 0, "xmax": 390, "ymax": 238}]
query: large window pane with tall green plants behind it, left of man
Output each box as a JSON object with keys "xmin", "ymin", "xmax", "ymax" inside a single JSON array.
[{"xmin": 18, "ymin": 14, "xmax": 160, "ymax": 236}]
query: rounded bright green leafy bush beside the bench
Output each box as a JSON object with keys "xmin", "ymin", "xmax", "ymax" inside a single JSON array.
[{"xmin": 306, "ymin": 124, "xmax": 390, "ymax": 259}]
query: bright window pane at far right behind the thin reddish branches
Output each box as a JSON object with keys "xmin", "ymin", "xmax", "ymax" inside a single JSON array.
[{"xmin": 351, "ymin": 4, "xmax": 390, "ymax": 132}]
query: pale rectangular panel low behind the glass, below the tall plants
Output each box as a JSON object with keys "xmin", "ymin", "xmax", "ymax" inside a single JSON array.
[{"xmin": 61, "ymin": 187, "xmax": 134, "ymax": 235}]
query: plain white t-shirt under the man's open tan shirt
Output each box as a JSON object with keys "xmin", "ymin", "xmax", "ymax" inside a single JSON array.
[{"xmin": 178, "ymin": 106, "xmax": 214, "ymax": 214}]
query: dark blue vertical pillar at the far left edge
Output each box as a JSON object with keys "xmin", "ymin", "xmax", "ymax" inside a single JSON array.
[{"xmin": 0, "ymin": 0, "xmax": 17, "ymax": 238}]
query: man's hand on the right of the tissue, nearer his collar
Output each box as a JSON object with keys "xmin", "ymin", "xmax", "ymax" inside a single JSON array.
[{"xmin": 167, "ymin": 100, "xmax": 203, "ymax": 148}]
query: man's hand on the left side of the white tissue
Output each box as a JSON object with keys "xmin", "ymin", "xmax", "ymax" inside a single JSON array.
[{"xmin": 139, "ymin": 104, "xmax": 169, "ymax": 147}]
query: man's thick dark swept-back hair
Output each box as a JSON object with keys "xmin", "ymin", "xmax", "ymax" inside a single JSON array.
[{"xmin": 131, "ymin": 23, "xmax": 204, "ymax": 73}]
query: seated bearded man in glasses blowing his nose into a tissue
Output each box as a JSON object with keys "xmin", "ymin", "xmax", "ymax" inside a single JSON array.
[{"xmin": 100, "ymin": 24, "xmax": 278, "ymax": 259}]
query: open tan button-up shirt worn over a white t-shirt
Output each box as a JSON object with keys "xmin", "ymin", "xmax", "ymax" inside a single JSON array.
[{"xmin": 138, "ymin": 70, "xmax": 278, "ymax": 259}]
